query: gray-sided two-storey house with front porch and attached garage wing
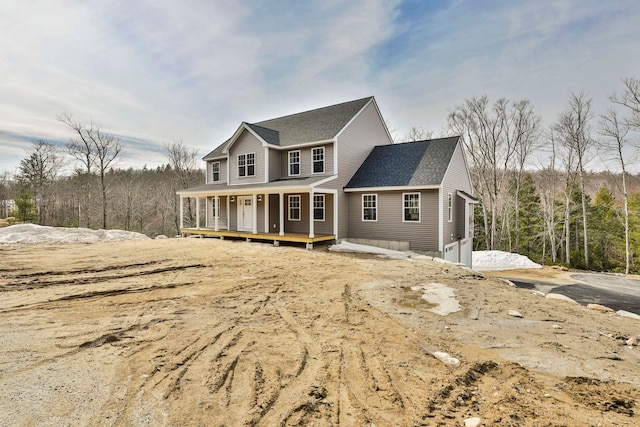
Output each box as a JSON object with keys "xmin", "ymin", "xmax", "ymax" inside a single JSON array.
[{"xmin": 178, "ymin": 97, "xmax": 476, "ymax": 265}]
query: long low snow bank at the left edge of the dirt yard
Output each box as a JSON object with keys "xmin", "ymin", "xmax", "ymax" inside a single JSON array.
[{"xmin": 0, "ymin": 224, "xmax": 148, "ymax": 244}]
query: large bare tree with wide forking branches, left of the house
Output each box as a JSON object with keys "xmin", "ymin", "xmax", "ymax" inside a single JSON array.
[{"xmin": 58, "ymin": 113, "xmax": 123, "ymax": 229}]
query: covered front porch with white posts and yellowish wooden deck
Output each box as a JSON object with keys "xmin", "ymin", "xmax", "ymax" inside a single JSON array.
[{"xmin": 180, "ymin": 187, "xmax": 338, "ymax": 248}]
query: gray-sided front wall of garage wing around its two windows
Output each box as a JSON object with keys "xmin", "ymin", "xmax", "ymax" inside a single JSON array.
[{"xmin": 343, "ymin": 190, "xmax": 439, "ymax": 251}]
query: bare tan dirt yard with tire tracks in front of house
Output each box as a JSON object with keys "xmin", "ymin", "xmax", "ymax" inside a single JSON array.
[{"xmin": 0, "ymin": 239, "xmax": 640, "ymax": 426}]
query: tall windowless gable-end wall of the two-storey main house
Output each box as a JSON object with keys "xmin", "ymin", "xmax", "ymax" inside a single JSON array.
[{"xmin": 324, "ymin": 102, "xmax": 392, "ymax": 239}]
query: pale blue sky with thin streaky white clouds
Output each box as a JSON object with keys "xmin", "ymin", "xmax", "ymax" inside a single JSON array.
[{"xmin": 0, "ymin": 0, "xmax": 640, "ymax": 174}]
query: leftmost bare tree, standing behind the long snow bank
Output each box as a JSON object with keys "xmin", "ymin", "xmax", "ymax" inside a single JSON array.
[{"xmin": 18, "ymin": 140, "xmax": 62, "ymax": 224}]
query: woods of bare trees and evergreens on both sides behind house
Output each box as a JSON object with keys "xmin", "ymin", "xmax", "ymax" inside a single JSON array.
[{"xmin": 0, "ymin": 78, "xmax": 640, "ymax": 274}]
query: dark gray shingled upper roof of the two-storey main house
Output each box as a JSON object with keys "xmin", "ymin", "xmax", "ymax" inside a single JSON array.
[{"xmin": 203, "ymin": 96, "xmax": 373, "ymax": 160}]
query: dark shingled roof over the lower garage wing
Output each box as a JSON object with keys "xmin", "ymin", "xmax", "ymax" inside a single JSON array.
[{"xmin": 345, "ymin": 136, "xmax": 459, "ymax": 188}]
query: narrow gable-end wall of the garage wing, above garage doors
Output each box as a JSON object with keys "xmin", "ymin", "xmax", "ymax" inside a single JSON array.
[{"xmin": 441, "ymin": 143, "xmax": 472, "ymax": 246}]
